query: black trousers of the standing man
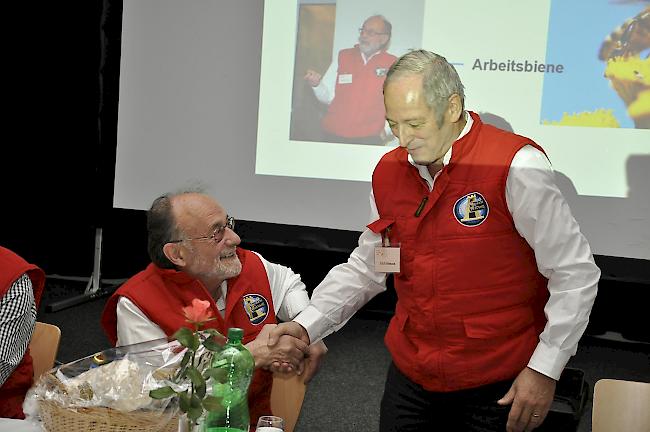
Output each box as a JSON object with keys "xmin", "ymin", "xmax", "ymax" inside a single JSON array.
[{"xmin": 379, "ymin": 363, "xmax": 520, "ymax": 432}]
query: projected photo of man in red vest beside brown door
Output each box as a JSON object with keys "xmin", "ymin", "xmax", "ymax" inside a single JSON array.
[{"xmin": 291, "ymin": 1, "xmax": 421, "ymax": 145}]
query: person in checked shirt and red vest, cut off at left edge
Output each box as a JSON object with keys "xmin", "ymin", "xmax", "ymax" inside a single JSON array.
[{"xmin": 0, "ymin": 246, "xmax": 45, "ymax": 419}]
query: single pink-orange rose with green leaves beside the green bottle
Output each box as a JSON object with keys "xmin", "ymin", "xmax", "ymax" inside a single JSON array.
[{"xmin": 149, "ymin": 299, "xmax": 225, "ymax": 429}]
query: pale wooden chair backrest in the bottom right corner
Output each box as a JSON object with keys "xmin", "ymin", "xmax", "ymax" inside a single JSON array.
[{"xmin": 591, "ymin": 379, "xmax": 650, "ymax": 432}]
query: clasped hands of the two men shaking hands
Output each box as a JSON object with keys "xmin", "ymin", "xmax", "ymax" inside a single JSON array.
[{"xmin": 246, "ymin": 321, "xmax": 327, "ymax": 383}]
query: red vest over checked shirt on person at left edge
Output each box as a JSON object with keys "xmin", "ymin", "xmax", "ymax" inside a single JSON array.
[{"xmin": 0, "ymin": 246, "xmax": 45, "ymax": 419}]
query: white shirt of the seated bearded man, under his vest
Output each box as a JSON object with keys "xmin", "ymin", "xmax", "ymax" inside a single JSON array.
[{"xmin": 117, "ymin": 252, "xmax": 309, "ymax": 346}]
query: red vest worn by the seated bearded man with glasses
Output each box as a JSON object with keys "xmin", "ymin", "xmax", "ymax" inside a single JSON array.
[{"xmin": 101, "ymin": 248, "xmax": 277, "ymax": 429}]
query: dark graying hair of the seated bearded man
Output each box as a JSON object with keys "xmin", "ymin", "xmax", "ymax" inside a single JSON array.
[{"xmin": 147, "ymin": 187, "xmax": 204, "ymax": 269}]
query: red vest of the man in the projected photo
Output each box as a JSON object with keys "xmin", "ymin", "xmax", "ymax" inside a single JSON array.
[{"xmin": 323, "ymin": 45, "xmax": 397, "ymax": 138}]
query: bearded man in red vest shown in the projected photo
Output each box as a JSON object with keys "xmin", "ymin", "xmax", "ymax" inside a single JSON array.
[{"xmin": 304, "ymin": 15, "xmax": 397, "ymax": 145}]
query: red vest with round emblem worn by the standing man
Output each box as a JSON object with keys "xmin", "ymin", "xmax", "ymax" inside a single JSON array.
[{"xmin": 368, "ymin": 113, "xmax": 548, "ymax": 392}]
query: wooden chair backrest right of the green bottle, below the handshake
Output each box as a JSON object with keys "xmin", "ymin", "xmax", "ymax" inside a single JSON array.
[{"xmin": 271, "ymin": 375, "xmax": 306, "ymax": 432}]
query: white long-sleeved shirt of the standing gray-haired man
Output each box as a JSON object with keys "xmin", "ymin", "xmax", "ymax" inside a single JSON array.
[{"xmin": 294, "ymin": 114, "xmax": 600, "ymax": 380}]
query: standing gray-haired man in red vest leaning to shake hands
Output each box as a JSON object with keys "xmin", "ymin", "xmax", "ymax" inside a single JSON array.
[{"xmin": 270, "ymin": 50, "xmax": 600, "ymax": 432}]
